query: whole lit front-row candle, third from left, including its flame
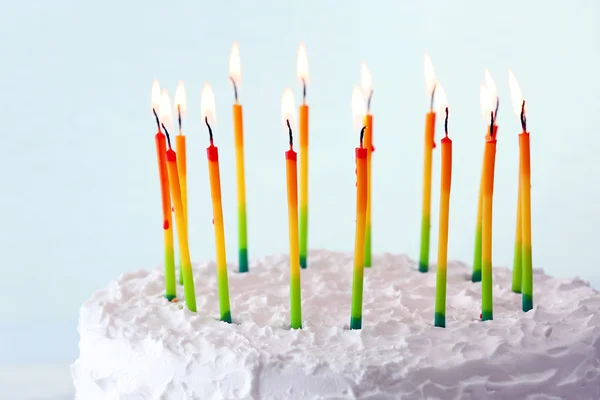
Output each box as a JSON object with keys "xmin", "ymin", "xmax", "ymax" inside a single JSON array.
[{"xmin": 200, "ymin": 83, "xmax": 231, "ymax": 323}]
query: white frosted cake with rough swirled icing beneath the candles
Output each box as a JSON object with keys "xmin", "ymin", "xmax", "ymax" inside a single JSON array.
[{"xmin": 71, "ymin": 251, "xmax": 600, "ymax": 400}]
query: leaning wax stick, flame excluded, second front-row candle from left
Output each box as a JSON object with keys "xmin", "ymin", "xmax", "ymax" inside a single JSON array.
[{"xmin": 167, "ymin": 150, "xmax": 196, "ymax": 312}]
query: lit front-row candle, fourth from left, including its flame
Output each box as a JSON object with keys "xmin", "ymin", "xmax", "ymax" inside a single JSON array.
[{"xmin": 281, "ymin": 89, "xmax": 302, "ymax": 329}]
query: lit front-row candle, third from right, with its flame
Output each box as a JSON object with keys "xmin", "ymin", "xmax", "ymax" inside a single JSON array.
[{"xmin": 434, "ymin": 83, "xmax": 452, "ymax": 328}]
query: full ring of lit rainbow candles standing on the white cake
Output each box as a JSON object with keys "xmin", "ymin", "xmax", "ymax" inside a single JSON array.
[{"xmin": 152, "ymin": 43, "xmax": 533, "ymax": 329}]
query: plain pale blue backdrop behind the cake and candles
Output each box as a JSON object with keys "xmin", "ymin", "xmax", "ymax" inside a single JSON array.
[{"xmin": 0, "ymin": 0, "xmax": 600, "ymax": 394}]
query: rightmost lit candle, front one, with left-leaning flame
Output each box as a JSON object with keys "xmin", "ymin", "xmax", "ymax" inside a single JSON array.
[{"xmin": 508, "ymin": 70, "xmax": 533, "ymax": 312}]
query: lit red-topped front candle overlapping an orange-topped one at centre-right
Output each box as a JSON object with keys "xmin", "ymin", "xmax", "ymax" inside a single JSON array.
[{"xmin": 350, "ymin": 86, "xmax": 368, "ymax": 329}]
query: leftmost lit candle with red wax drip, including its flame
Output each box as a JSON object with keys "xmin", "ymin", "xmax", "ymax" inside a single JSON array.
[{"xmin": 152, "ymin": 80, "xmax": 177, "ymax": 301}]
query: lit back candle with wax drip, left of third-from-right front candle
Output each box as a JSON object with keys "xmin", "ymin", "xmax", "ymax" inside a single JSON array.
[{"xmin": 419, "ymin": 53, "xmax": 437, "ymax": 272}]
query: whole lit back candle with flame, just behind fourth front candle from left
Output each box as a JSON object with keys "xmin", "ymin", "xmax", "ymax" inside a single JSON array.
[{"xmin": 297, "ymin": 43, "xmax": 309, "ymax": 268}]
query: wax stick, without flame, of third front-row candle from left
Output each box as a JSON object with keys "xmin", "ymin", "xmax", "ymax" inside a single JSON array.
[{"xmin": 206, "ymin": 144, "xmax": 231, "ymax": 322}]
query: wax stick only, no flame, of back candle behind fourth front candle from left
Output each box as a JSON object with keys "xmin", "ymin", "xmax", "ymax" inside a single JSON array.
[{"xmin": 299, "ymin": 104, "xmax": 308, "ymax": 268}]
